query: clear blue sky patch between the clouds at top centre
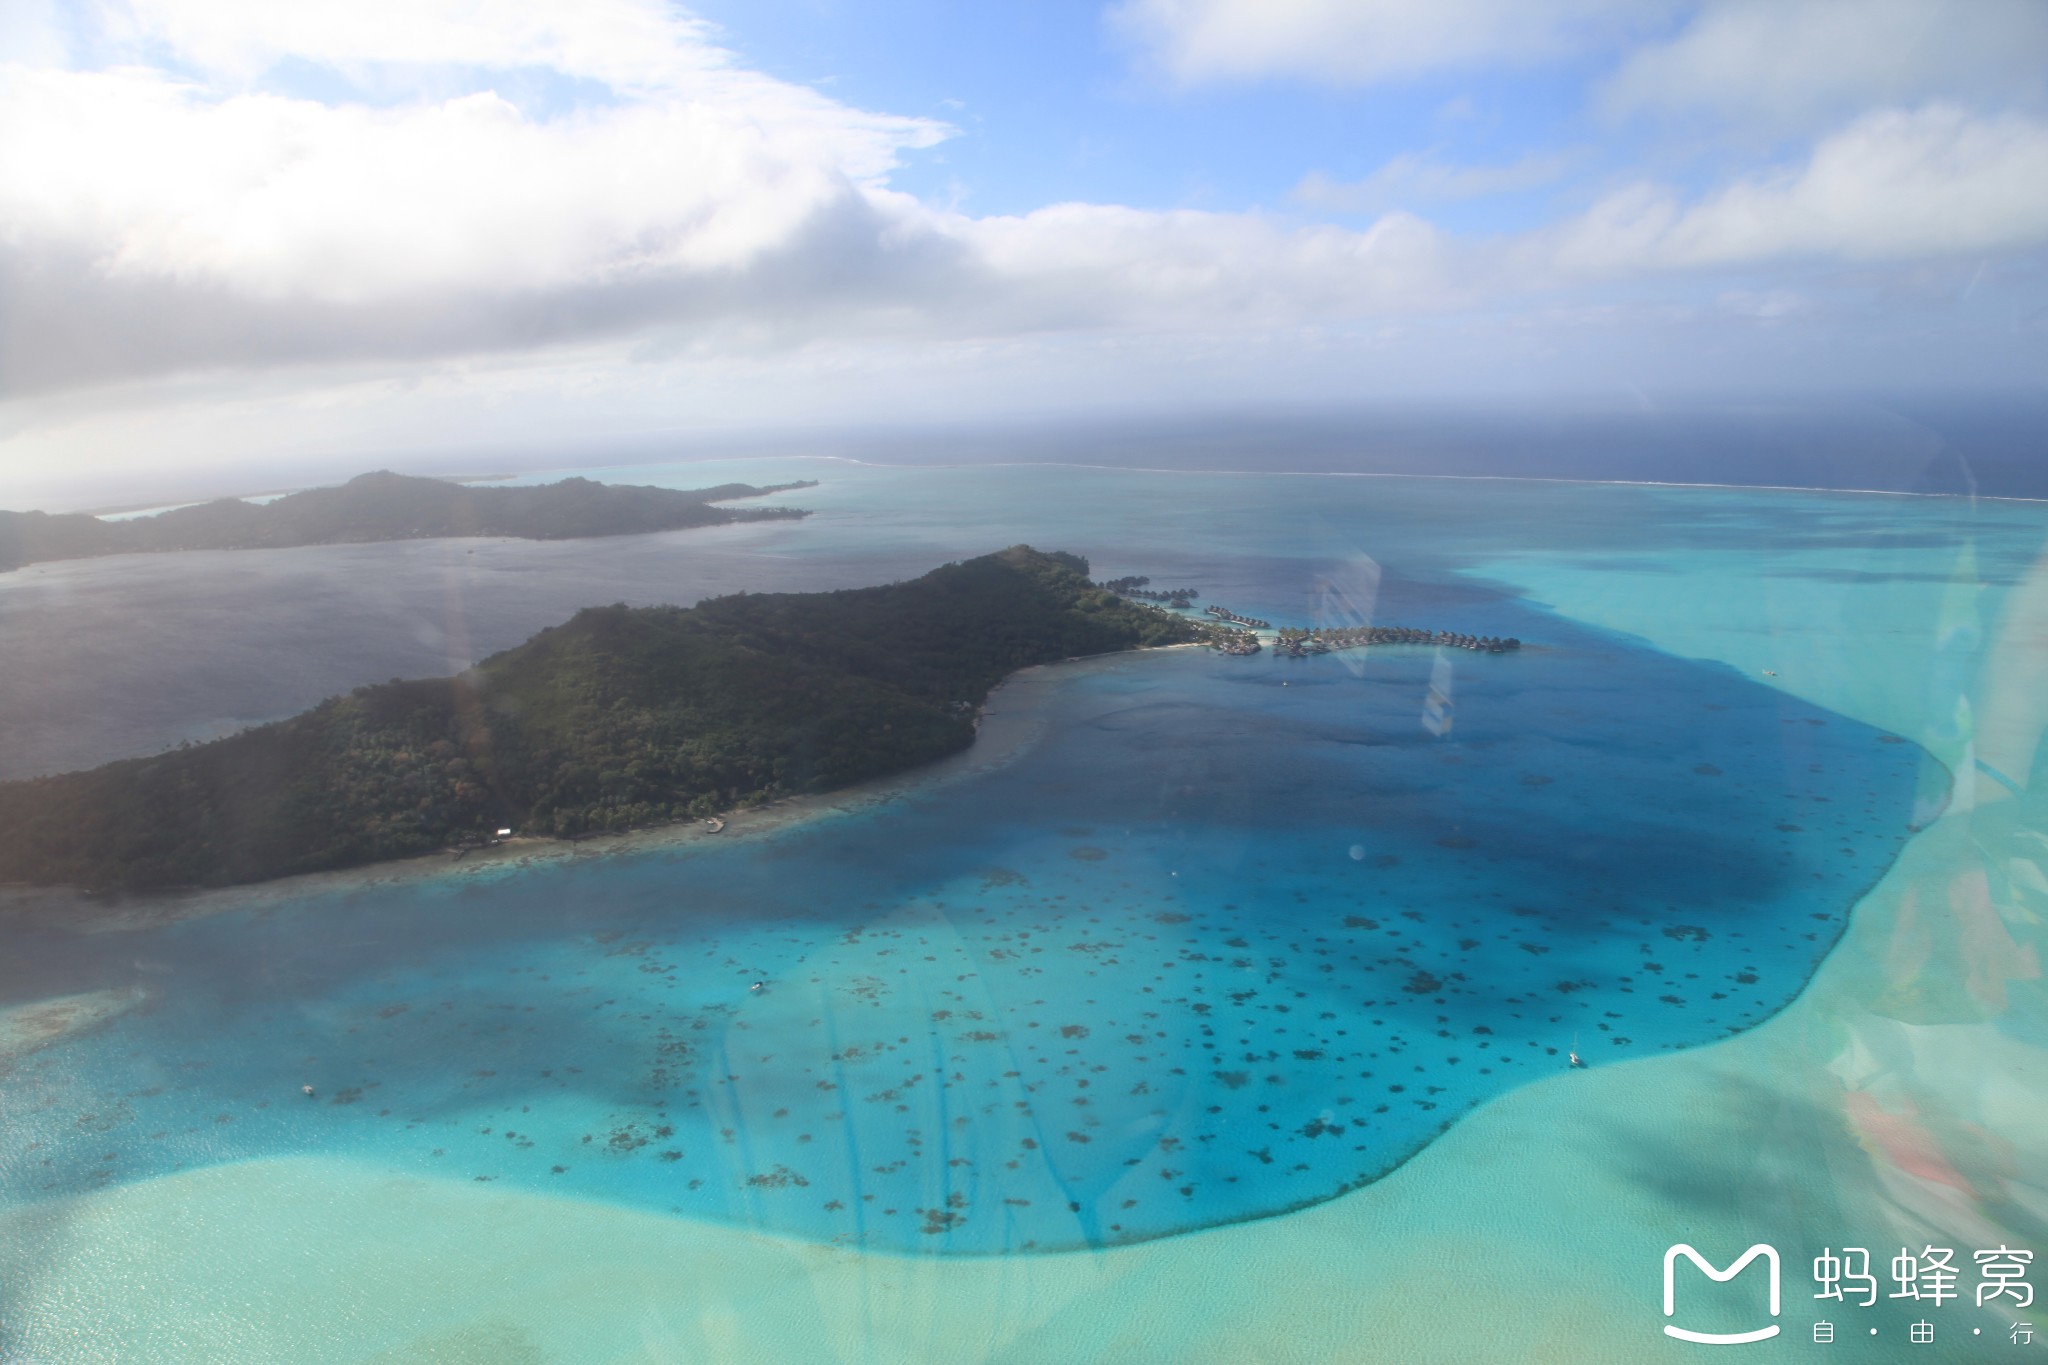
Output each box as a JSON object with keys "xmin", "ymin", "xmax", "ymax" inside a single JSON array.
[{"xmin": 679, "ymin": 0, "xmax": 1640, "ymax": 231}]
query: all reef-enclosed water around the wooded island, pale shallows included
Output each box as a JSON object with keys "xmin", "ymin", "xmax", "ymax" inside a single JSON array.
[{"xmin": 0, "ymin": 458, "xmax": 2048, "ymax": 1359}]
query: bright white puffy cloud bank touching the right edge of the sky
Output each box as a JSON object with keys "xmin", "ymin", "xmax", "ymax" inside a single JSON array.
[{"xmin": 1524, "ymin": 104, "xmax": 2048, "ymax": 276}]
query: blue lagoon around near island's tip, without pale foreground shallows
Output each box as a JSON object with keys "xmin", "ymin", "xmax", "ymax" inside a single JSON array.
[{"xmin": 0, "ymin": 463, "xmax": 2044, "ymax": 1359}]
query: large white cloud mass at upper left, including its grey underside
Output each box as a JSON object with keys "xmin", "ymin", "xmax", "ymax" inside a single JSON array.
[{"xmin": 0, "ymin": 0, "xmax": 948, "ymax": 393}]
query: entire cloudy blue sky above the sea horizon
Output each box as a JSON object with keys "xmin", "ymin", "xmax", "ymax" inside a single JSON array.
[{"xmin": 0, "ymin": 0, "xmax": 2048, "ymax": 505}]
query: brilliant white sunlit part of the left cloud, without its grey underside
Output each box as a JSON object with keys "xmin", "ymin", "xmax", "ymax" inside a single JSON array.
[{"xmin": 0, "ymin": 72, "xmax": 938, "ymax": 305}]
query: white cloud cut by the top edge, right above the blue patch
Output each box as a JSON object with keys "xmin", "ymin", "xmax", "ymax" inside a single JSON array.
[{"xmin": 1110, "ymin": 0, "xmax": 1671, "ymax": 86}]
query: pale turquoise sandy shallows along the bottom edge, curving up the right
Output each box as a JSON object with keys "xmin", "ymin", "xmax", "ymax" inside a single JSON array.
[{"xmin": 0, "ymin": 557, "xmax": 2048, "ymax": 1363}]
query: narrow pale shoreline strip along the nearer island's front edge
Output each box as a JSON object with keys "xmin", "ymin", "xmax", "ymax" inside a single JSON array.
[{"xmin": 0, "ymin": 643, "xmax": 1206, "ymax": 933}]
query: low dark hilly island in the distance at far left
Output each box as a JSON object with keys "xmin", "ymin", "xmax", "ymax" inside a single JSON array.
[{"xmin": 0, "ymin": 471, "xmax": 817, "ymax": 573}]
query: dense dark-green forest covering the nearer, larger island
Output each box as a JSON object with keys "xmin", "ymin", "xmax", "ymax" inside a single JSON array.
[{"xmin": 0, "ymin": 546, "xmax": 1202, "ymax": 888}]
